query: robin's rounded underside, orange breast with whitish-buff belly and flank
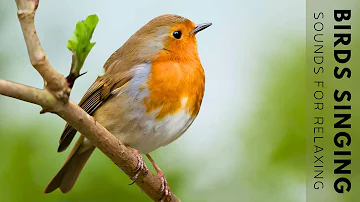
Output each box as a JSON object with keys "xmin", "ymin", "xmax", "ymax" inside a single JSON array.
[{"xmin": 107, "ymin": 63, "xmax": 204, "ymax": 153}]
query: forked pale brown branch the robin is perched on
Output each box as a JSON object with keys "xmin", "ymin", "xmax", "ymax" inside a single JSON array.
[{"xmin": 0, "ymin": 0, "xmax": 180, "ymax": 202}]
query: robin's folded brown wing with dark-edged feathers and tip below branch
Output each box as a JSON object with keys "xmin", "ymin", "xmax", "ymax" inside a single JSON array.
[{"xmin": 58, "ymin": 73, "xmax": 133, "ymax": 152}]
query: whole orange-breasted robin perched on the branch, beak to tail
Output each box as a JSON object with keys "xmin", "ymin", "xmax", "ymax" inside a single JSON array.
[{"xmin": 44, "ymin": 14, "xmax": 212, "ymax": 199}]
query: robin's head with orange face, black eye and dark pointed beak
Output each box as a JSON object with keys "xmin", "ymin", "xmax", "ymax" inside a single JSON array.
[{"xmin": 129, "ymin": 14, "xmax": 211, "ymax": 60}]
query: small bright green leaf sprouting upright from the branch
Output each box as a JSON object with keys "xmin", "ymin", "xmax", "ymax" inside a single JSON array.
[{"xmin": 67, "ymin": 15, "xmax": 99, "ymax": 77}]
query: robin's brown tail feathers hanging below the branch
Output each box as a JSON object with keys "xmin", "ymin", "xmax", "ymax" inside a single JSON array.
[{"xmin": 44, "ymin": 135, "xmax": 95, "ymax": 193}]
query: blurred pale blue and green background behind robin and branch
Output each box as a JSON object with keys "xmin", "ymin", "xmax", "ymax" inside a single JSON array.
[{"xmin": 4, "ymin": 0, "xmax": 359, "ymax": 202}]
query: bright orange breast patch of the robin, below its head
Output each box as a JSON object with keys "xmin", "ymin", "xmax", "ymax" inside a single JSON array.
[{"xmin": 144, "ymin": 57, "xmax": 205, "ymax": 120}]
